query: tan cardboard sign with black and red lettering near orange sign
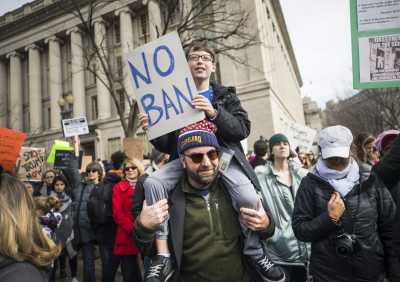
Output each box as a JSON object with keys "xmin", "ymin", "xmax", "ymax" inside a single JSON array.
[{"xmin": 18, "ymin": 147, "xmax": 46, "ymax": 181}]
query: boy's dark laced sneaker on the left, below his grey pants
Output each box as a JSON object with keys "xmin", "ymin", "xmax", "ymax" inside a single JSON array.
[{"xmin": 144, "ymin": 255, "xmax": 175, "ymax": 282}]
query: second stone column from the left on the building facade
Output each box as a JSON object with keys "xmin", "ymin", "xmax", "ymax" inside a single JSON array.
[{"xmin": 25, "ymin": 44, "xmax": 42, "ymax": 133}]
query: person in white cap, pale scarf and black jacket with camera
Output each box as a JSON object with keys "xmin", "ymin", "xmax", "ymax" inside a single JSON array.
[{"xmin": 292, "ymin": 125, "xmax": 398, "ymax": 282}]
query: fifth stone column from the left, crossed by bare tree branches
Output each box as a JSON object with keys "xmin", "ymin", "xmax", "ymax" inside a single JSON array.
[{"xmin": 93, "ymin": 17, "xmax": 111, "ymax": 119}]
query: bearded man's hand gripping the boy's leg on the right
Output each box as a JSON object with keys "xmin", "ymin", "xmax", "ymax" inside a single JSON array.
[{"xmin": 240, "ymin": 201, "xmax": 270, "ymax": 231}]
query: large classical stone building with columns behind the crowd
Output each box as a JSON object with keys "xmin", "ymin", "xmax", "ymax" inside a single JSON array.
[{"xmin": 0, "ymin": 0, "xmax": 304, "ymax": 159}]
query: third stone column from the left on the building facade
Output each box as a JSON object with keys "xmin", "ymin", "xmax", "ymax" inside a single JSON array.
[{"xmin": 45, "ymin": 36, "xmax": 62, "ymax": 130}]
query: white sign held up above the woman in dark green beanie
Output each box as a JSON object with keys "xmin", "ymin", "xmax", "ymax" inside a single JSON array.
[{"xmin": 280, "ymin": 117, "xmax": 317, "ymax": 152}]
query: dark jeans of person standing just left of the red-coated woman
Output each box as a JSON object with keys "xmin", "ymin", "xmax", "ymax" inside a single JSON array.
[{"xmin": 99, "ymin": 244, "xmax": 121, "ymax": 282}]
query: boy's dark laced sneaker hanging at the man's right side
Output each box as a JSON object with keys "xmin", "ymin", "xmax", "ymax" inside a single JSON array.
[{"xmin": 251, "ymin": 254, "xmax": 285, "ymax": 282}]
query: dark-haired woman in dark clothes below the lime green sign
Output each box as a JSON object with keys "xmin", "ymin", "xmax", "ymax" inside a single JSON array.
[{"xmin": 50, "ymin": 175, "xmax": 78, "ymax": 282}]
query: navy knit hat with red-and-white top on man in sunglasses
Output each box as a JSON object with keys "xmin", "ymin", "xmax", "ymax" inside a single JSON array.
[{"xmin": 178, "ymin": 119, "xmax": 219, "ymax": 154}]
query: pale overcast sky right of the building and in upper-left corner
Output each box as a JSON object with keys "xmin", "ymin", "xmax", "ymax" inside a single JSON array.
[{"xmin": 0, "ymin": 0, "xmax": 352, "ymax": 106}]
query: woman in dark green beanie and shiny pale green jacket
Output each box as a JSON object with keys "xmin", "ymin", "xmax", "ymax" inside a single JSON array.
[{"xmin": 255, "ymin": 134, "xmax": 310, "ymax": 282}]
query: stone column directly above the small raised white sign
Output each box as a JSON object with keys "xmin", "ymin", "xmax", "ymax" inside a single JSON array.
[{"xmin": 67, "ymin": 27, "xmax": 86, "ymax": 117}]
